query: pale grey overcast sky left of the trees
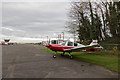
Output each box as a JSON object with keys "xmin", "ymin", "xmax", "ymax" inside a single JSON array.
[{"xmin": 1, "ymin": 2, "xmax": 70, "ymax": 42}]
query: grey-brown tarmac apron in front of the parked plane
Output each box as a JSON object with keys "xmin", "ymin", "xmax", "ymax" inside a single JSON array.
[{"xmin": 2, "ymin": 44, "xmax": 118, "ymax": 78}]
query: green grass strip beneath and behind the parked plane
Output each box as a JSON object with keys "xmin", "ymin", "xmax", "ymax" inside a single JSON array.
[{"xmin": 42, "ymin": 49, "xmax": 120, "ymax": 72}]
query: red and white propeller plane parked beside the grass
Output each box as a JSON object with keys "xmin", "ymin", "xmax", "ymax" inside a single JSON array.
[{"xmin": 46, "ymin": 40, "xmax": 103, "ymax": 59}]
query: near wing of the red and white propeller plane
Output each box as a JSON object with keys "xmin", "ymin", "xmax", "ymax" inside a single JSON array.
[{"xmin": 64, "ymin": 45, "xmax": 99, "ymax": 52}]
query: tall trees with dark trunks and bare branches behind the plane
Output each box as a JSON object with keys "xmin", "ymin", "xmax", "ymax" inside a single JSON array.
[{"xmin": 68, "ymin": 0, "xmax": 120, "ymax": 40}]
